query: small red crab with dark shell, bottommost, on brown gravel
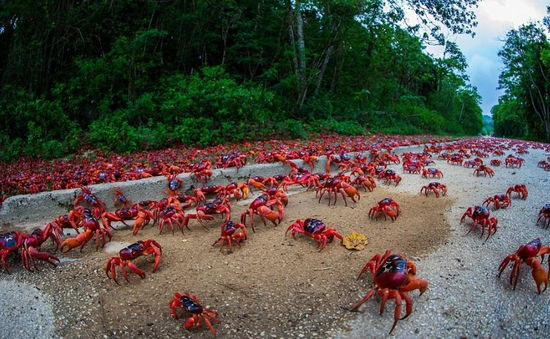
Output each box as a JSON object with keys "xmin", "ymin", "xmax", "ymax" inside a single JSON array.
[{"xmin": 170, "ymin": 292, "xmax": 220, "ymax": 337}]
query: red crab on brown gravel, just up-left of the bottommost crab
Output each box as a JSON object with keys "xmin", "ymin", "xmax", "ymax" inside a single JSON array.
[{"xmin": 105, "ymin": 239, "xmax": 162, "ymax": 285}]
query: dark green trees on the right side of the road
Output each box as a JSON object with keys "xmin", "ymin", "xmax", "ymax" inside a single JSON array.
[{"xmin": 491, "ymin": 7, "xmax": 550, "ymax": 142}]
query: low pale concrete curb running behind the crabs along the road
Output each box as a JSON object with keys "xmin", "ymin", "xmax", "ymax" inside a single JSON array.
[{"xmin": 0, "ymin": 146, "xmax": 424, "ymax": 231}]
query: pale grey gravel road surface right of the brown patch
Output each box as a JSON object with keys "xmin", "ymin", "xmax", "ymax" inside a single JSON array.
[{"xmin": 332, "ymin": 139, "xmax": 550, "ymax": 339}]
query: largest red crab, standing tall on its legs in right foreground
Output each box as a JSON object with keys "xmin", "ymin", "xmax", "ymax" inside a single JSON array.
[{"xmin": 351, "ymin": 250, "xmax": 428, "ymax": 334}]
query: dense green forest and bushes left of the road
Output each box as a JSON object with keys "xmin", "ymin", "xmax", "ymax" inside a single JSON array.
[{"xmin": 0, "ymin": 0, "xmax": 483, "ymax": 161}]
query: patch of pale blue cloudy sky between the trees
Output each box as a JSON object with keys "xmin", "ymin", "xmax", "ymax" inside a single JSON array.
[{"xmin": 427, "ymin": 0, "xmax": 550, "ymax": 115}]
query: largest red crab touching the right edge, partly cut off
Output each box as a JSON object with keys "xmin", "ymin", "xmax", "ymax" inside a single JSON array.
[{"xmin": 498, "ymin": 238, "xmax": 550, "ymax": 294}]
